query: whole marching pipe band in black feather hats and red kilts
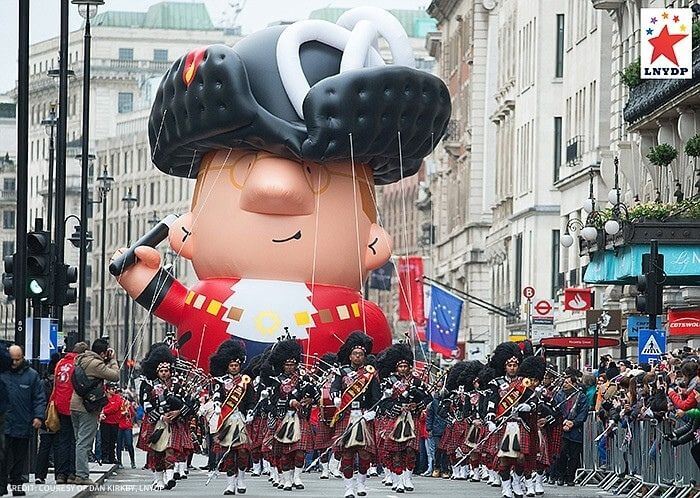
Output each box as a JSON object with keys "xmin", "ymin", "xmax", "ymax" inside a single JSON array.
[{"xmin": 129, "ymin": 331, "xmax": 568, "ymax": 498}]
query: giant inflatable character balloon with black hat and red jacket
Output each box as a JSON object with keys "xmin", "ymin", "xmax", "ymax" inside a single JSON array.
[{"xmin": 111, "ymin": 7, "xmax": 450, "ymax": 369}]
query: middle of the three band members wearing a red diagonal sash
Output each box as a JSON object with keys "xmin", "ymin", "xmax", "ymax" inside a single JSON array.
[{"xmin": 331, "ymin": 331, "xmax": 381, "ymax": 498}]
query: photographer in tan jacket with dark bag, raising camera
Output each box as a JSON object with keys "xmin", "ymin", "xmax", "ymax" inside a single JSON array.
[{"xmin": 70, "ymin": 338, "xmax": 119, "ymax": 485}]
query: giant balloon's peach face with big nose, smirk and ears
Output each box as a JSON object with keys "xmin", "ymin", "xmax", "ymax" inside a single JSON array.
[{"xmin": 171, "ymin": 150, "xmax": 391, "ymax": 289}]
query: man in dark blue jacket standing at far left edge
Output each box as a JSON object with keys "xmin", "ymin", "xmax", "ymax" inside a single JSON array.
[{"xmin": 0, "ymin": 345, "xmax": 46, "ymax": 496}]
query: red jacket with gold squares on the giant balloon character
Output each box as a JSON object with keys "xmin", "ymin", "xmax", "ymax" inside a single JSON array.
[{"xmin": 141, "ymin": 270, "xmax": 391, "ymax": 371}]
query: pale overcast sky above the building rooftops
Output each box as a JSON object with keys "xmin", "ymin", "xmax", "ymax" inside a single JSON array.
[{"xmin": 0, "ymin": 0, "xmax": 430, "ymax": 93}]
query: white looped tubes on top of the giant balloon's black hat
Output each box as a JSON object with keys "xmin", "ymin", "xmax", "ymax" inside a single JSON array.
[{"xmin": 277, "ymin": 7, "xmax": 415, "ymax": 119}]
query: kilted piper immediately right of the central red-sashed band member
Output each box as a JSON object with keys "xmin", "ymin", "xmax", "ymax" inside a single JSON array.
[{"xmin": 375, "ymin": 343, "xmax": 432, "ymax": 493}]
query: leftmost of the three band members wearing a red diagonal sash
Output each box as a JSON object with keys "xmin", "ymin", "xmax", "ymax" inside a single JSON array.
[{"xmin": 209, "ymin": 339, "xmax": 255, "ymax": 495}]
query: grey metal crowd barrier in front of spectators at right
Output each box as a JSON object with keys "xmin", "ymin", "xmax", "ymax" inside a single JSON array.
[{"xmin": 576, "ymin": 412, "xmax": 700, "ymax": 498}]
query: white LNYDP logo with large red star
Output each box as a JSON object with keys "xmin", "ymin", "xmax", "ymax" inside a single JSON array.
[{"xmin": 641, "ymin": 9, "xmax": 693, "ymax": 79}]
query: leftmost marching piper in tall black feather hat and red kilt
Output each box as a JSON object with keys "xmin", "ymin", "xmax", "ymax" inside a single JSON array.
[{"xmin": 137, "ymin": 343, "xmax": 193, "ymax": 490}]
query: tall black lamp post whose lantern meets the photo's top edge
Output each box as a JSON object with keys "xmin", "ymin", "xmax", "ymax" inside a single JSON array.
[{"xmin": 71, "ymin": 0, "xmax": 104, "ymax": 341}]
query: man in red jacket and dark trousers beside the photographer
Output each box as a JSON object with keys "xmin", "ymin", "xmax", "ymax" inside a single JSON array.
[{"xmin": 51, "ymin": 342, "xmax": 87, "ymax": 484}]
